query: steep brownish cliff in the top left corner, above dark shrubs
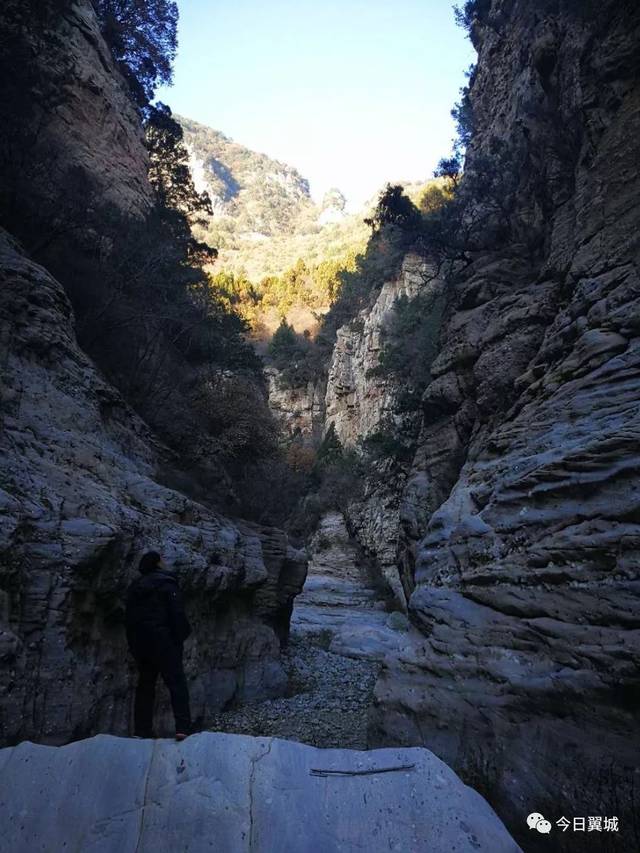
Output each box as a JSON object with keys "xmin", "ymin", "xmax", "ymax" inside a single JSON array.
[{"xmin": 0, "ymin": 0, "xmax": 152, "ymax": 223}]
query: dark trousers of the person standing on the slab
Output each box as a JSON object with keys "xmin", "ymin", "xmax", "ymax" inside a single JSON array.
[{"xmin": 134, "ymin": 643, "xmax": 191, "ymax": 737}]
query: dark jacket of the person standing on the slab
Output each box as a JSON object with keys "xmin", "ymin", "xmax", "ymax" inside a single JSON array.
[{"xmin": 125, "ymin": 569, "xmax": 191, "ymax": 653}]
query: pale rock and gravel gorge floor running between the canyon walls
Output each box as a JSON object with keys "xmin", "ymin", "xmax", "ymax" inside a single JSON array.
[{"xmin": 205, "ymin": 512, "xmax": 423, "ymax": 749}]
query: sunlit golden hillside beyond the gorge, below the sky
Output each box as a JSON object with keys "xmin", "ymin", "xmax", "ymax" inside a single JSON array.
[{"xmin": 180, "ymin": 118, "xmax": 450, "ymax": 340}]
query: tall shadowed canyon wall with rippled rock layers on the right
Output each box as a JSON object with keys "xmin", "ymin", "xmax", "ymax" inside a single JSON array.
[{"xmin": 374, "ymin": 0, "xmax": 640, "ymax": 847}]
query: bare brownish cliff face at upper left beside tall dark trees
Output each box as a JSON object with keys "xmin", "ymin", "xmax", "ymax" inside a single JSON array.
[{"xmin": 0, "ymin": 0, "xmax": 152, "ymax": 220}]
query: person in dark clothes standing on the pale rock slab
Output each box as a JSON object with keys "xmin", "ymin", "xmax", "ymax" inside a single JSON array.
[{"xmin": 125, "ymin": 551, "xmax": 191, "ymax": 740}]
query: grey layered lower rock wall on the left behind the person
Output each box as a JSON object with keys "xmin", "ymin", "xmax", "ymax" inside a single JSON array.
[{"xmin": 0, "ymin": 234, "xmax": 306, "ymax": 742}]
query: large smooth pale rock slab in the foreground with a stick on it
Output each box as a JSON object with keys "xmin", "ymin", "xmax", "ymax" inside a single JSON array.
[{"xmin": 0, "ymin": 732, "xmax": 520, "ymax": 853}]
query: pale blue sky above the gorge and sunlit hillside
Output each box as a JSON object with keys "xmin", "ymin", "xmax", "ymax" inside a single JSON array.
[{"xmin": 156, "ymin": 0, "xmax": 475, "ymax": 208}]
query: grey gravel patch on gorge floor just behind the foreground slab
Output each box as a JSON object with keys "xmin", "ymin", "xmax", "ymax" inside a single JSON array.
[{"xmin": 210, "ymin": 636, "xmax": 379, "ymax": 749}]
